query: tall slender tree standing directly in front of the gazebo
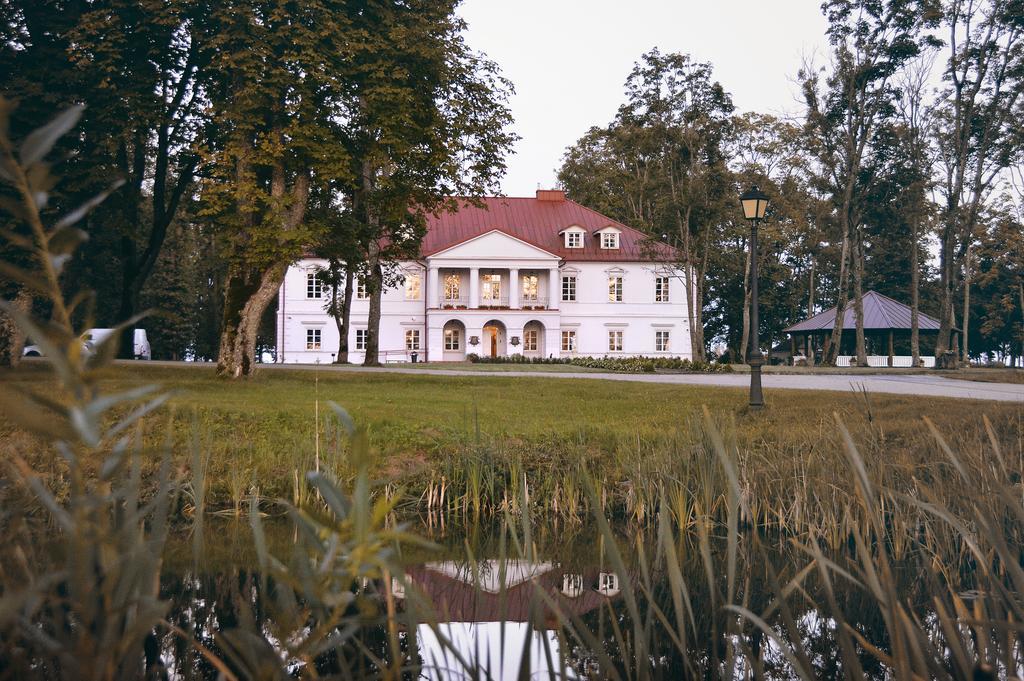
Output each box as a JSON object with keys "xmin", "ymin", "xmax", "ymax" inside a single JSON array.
[{"xmin": 799, "ymin": 0, "xmax": 934, "ymax": 364}]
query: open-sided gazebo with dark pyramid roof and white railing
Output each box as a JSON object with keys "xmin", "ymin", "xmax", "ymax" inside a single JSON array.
[{"xmin": 782, "ymin": 291, "xmax": 958, "ymax": 367}]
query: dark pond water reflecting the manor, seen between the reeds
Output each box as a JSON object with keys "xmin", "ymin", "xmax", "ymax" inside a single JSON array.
[{"xmin": 149, "ymin": 521, "xmax": 936, "ymax": 680}]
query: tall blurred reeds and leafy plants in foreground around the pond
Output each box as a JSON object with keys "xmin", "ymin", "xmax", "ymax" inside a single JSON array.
[{"xmin": 0, "ymin": 102, "xmax": 1024, "ymax": 680}]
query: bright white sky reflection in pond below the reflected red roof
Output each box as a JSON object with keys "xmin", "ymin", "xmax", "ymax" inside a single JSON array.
[{"xmin": 416, "ymin": 622, "xmax": 580, "ymax": 681}]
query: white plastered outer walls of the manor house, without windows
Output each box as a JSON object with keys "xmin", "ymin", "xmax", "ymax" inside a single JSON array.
[{"xmin": 278, "ymin": 257, "xmax": 691, "ymax": 364}]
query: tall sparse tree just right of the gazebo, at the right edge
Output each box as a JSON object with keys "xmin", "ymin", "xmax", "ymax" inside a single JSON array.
[{"xmin": 933, "ymin": 0, "xmax": 1024, "ymax": 356}]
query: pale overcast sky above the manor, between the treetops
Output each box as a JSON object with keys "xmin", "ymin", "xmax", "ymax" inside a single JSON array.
[{"xmin": 461, "ymin": 0, "xmax": 826, "ymax": 196}]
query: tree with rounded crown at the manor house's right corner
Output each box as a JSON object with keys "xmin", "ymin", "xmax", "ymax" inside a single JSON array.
[{"xmin": 558, "ymin": 49, "xmax": 735, "ymax": 359}]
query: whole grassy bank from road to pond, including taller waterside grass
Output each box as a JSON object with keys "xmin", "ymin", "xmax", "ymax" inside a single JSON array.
[{"xmin": 0, "ymin": 365, "xmax": 1024, "ymax": 519}]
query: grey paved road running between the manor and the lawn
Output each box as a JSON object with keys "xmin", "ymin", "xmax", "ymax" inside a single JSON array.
[{"xmin": 241, "ymin": 363, "xmax": 1024, "ymax": 403}]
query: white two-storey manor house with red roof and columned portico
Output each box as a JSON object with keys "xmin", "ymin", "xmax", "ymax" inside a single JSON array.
[{"xmin": 276, "ymin": 189, "xmax": 691, "ymax": 364}]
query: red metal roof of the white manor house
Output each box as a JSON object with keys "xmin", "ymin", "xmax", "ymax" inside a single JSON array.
[{"xmin": 421, "ymin": 189, "xmax": 676, "ymax": 262}]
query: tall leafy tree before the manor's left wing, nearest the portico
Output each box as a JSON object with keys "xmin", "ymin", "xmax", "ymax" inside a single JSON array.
[{"xmin": 345, "ymin": 0, "xmax": 516, "ymax": 366}]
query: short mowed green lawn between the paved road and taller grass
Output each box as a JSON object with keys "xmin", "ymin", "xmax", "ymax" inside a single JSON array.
[{"xmin": 0, "ymin": 364, "xmax": 1022, "ymax": 509}]
